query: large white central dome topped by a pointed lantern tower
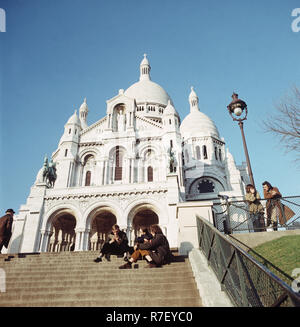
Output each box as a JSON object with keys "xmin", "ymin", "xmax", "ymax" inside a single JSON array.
[{"xmin": 124, "ymin": 55, "xmax": 172, "ymax": 106}]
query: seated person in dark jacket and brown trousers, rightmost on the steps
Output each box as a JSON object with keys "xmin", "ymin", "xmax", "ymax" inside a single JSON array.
[{"xmin": 119, "ymin": 225, "xmax": 172, "ymax": 269}]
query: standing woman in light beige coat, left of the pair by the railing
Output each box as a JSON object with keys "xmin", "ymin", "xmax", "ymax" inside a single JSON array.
[{"xmin": 245, "ymin": 184, "xmax": 265, "ymax": 232}]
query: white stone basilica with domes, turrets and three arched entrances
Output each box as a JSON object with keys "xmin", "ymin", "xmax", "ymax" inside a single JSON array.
[{"xmin": 9, "ymin": 55, "xmax": 249, "ymax": 253}]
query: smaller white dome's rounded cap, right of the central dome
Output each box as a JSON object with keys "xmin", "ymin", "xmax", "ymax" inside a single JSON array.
[{"xmin": 180, "ymin": 111, "xmax": 219, "ymax": 138}]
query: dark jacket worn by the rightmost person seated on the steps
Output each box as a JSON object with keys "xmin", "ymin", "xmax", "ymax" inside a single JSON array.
[{"xmin": 139, "ymin": 234, "xmax": 172, "ymax": 265}]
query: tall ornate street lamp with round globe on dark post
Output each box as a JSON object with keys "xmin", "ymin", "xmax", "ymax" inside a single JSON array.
[{"xmin": 227, "ymin": 92, "xmax": 255, "ymax": 187}]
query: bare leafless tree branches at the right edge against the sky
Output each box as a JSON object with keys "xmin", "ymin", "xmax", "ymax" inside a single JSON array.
[{"xmin": 263, "ymin": 87, "xmax": 300, "ymax": 163}]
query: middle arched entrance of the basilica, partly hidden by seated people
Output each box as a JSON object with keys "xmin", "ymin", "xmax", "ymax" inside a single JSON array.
[{"xmin": 89, "ymin": 208, "xmax": 117, "ymax": 251}]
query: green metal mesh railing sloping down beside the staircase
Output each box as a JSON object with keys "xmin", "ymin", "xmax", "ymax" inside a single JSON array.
[{"xmin": 197, "ymin": 217, "xmax": 300, "ymax": 307}]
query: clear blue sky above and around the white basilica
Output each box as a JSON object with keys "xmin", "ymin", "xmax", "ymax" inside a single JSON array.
[{"xmin": 0, "ymin": 0, "xmax": 300, "ymax": 211}]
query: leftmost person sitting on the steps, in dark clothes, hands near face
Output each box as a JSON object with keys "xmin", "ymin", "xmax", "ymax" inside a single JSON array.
[{"xmin": 94, "ymin": 224, "xmax": 130, "ymax": 262}]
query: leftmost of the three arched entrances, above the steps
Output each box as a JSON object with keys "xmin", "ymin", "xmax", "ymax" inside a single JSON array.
[{"xmin": 48, "ymin": 210, "xmax": 76, "ymax": 252}]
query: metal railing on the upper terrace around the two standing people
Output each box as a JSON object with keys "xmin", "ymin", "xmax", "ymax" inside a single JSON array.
[{"xmin": 214, "ymin": 196, "xmax": 300, "ymax": 233}]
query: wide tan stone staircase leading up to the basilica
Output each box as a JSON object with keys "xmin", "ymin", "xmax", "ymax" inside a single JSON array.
[{"xmin": 0, "ymin": 251, "xmax": 202, "ymax": 307}]
